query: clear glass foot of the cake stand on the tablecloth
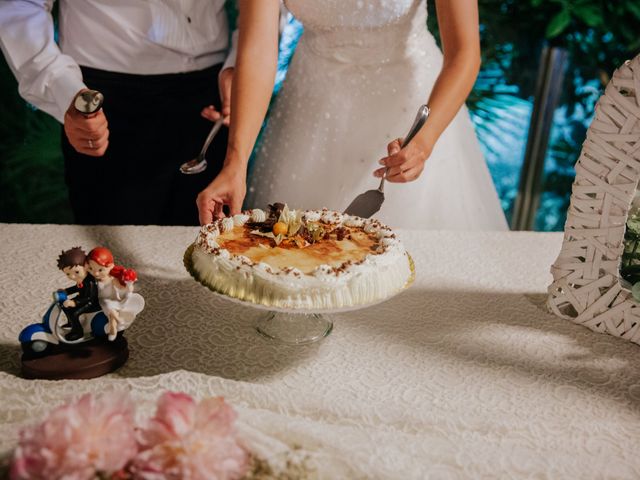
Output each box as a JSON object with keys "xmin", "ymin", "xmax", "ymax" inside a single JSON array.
[{"xmin": 256, "ymin": 312, "xmax": 333, "ymax": 345}]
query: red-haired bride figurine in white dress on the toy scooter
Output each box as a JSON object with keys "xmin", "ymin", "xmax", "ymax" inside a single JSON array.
[{"xmin": 87, "ymin": 247, "xmax": 144, "ymax": 341}]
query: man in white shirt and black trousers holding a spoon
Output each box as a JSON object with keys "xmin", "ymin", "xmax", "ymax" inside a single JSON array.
[{"xmin": 0, "ymin": 0, "xmax": 235, "ymax": 225}]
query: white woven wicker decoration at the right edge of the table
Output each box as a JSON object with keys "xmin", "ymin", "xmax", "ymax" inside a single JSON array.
[{"xmin": 547, "ymin": 55, "xmax": 640, "ymax": 344}]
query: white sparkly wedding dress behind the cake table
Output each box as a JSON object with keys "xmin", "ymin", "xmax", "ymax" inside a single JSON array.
[{"xmin": 245, "ymin": 0, "xmax": 507, "ymax": 230}]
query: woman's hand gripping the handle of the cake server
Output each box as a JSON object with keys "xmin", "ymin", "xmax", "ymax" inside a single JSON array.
[{"xmin": 373, "ymin": 140, "xmax": 431, "ymax": 183}]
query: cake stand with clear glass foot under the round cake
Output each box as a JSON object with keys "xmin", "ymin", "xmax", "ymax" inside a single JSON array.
[{"xmin": 184, "ymin": 245, "xmax": 415, "ymax": 345}]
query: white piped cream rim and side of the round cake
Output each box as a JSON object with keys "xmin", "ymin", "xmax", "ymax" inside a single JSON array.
[{"xmin": 192, "ymin": 209, "xmax": 412, "ymax": 309}]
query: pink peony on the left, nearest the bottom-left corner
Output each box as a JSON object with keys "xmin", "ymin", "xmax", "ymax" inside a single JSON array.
[{"xmin": 11, "ymin": 392, "xmax": 138, "ymax": 480}]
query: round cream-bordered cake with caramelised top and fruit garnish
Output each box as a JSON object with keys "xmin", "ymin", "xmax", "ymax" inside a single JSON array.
[{"xmin": 191, "ymin": 204, "xmax": 412, "ymax": 310}]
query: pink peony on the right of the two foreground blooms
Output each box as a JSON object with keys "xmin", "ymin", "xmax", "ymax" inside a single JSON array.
[{"xmin": 131, "ymin": 392, "xmax": 248, "ymax": 480}]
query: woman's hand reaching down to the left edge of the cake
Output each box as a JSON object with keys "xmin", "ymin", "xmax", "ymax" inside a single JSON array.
[{"xmin": 196, "ymin": 166, "xmax": 247, "ymax": 225}]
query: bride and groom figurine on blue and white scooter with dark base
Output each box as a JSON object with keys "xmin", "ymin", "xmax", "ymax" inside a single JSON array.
[{"xmin": 19, "ymin": 247, "xmax": 144, "ymax": 379}]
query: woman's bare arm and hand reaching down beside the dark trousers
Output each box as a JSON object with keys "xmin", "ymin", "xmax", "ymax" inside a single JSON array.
[{"xmin": 197, "ymin": 0, "xmax": 280, "ymax": 224}]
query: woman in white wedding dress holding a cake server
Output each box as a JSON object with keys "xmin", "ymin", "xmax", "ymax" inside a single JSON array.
[{"xmin": 198, "ymin": 0, "xmax": 507, "ymax": 230}]
